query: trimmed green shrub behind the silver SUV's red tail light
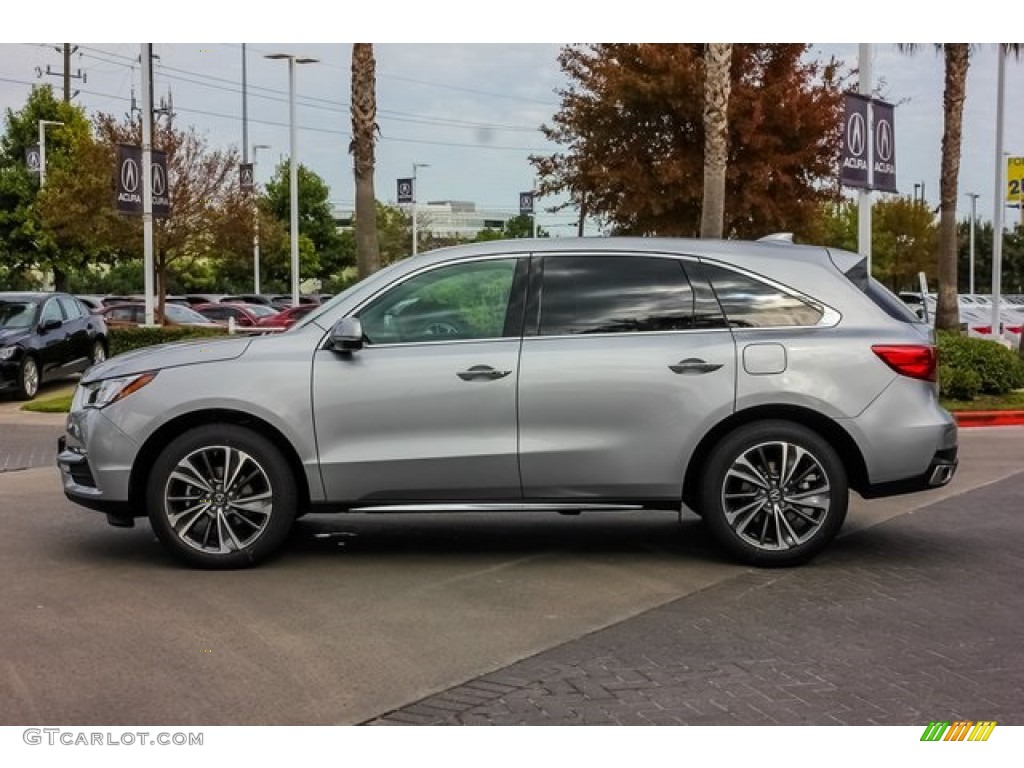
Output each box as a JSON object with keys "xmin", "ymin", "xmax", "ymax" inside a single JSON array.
[{"xmin": 939, "ymin": 332, "xmax": 1024, "ymax": 399}]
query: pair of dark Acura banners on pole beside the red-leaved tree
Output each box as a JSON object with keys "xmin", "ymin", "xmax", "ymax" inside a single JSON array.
[{"xmin": 840, "ymin": 93, "xmax": 897, "ymax": 193}]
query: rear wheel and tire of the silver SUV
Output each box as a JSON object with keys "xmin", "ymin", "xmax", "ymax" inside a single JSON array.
[{"xmin": 698, "ymin": 420, "xmax": 850, "ymax": 566}]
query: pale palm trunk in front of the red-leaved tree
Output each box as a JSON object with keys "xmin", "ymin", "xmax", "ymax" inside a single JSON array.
[{"xmin": 700, "ymin": 43, "xmax": 732, "ymax": 238}]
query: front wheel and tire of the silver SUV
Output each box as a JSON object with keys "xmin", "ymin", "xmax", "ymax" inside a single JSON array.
[{"xmin": 146, "ymin": 424, "xmax": 298, "ymax": 568}]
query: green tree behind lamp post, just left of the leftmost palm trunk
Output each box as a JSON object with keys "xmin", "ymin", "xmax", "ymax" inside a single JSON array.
[{"xmin": 266, "ymin": 160, "xmax": 351, "ymax": 280}]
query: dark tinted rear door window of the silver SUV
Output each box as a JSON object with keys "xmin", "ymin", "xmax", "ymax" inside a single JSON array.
[{"xmin": 541, "ymin": 256, "xmax": 693, "ymax": 336}]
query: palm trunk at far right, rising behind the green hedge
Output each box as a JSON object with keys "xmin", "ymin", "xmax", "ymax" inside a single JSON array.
[{"xmin": 935, "ymin": 43, "xmax": 970, "ymax": 331}]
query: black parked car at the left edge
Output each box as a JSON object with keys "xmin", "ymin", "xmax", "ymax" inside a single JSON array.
[{"xmin": 0, "ymin": 293, "xmax": 106, "ymax": 400}]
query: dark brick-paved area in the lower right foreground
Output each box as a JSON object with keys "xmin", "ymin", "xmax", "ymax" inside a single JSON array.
[{"xmin": 373, "ymin": 474, "xmax": 1024, "ymax": 725}]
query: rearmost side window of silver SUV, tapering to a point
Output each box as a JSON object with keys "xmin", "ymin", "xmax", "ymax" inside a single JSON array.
[{"xmin": 703, "ymin": 263, "xmax": 824, "ymax": 328}]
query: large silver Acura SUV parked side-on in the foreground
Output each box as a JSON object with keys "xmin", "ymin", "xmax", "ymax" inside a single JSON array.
[{"xmin": 57, "ymin": 239, "xmax": 956, "ymax": 567}]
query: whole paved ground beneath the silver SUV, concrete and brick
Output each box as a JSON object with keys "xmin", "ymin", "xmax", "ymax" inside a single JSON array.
[{"xmin": 0, "ymin": 403, "xmax": 1024, "ymax": 725}]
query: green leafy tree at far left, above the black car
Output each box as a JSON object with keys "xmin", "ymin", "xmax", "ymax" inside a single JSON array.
[{"xmin": 0, "ymin": 85, "xmax": 90, "ymax": 290}]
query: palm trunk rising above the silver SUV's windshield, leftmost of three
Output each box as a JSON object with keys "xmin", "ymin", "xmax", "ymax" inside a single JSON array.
[{"xmin": 348, "ymin": 43, "xmax": 380, "ymax": 278}]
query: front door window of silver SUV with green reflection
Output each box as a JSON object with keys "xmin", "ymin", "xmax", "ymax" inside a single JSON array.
[{"xmin": 358, "ymin": 259, "xmax": 518, "ymax": 344}]
